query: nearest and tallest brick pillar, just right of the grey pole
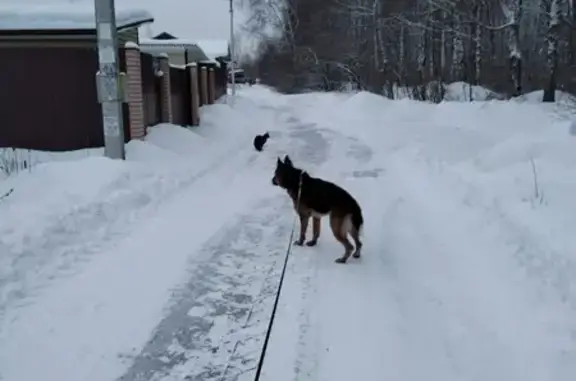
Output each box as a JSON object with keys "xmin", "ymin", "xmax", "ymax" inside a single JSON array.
[{"xmin": 126, "ymin": 43, "xmax": 146, "ymax": 139}]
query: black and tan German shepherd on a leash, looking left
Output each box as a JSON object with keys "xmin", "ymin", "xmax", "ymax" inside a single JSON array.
[{"xmin": 272, "ymin": 155, "xmax": 364, "ymax": 263}]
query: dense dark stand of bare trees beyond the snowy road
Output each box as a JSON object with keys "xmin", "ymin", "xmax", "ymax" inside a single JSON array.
[{"xmin": 244, "ymin": 0, "xmax": 576, "ymax": 101}]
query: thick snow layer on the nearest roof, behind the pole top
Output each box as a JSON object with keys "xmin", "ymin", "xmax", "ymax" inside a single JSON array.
[{"xmin": 0, "ymin": 2, "xmax": 154, "ymax": 31}]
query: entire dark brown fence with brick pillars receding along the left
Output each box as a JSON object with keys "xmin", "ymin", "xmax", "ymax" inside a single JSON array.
[{"xmin": 0, "ymin": 44, "xmax": 225, "ymax": 151}]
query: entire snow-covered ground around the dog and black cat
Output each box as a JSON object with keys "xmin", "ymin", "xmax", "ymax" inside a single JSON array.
[{"xmin": 0, "ymin": 86, "xmax": 576, "ymax": 381}]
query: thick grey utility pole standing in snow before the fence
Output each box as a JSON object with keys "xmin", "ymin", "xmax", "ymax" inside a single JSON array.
[{"xmin": 94, "ymin": 0, "xmax": 126, "ymax": 160}]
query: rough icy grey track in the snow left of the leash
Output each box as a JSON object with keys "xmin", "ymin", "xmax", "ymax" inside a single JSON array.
[{"xmin": 119, "ymin": 198, "xmax": 291, "ymax": 381}]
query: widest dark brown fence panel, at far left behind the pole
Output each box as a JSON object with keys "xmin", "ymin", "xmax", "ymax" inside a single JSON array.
[{"xmin": 0, "ymin": 46, "xmax": 130, "ymax": 151}]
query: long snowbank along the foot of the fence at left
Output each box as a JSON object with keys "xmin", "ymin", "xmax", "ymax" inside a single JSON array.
[{"xmin": 0, "ymin": 97, "xmax": 254, "ymax": 315}]
